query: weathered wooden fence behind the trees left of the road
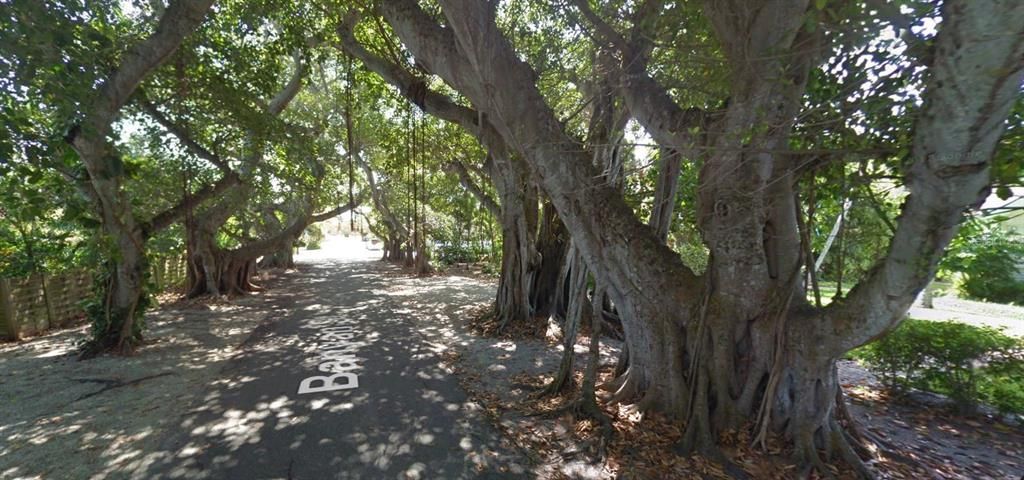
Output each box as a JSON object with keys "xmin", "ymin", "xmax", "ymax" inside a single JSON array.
[{"xmin": 0, "ymin": 256, "xmax": 186, "ymax": 340}]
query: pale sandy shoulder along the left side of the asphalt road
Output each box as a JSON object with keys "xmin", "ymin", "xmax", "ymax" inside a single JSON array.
[{"xmin": 0, "ymin": 272, "xmax": 290, "ymax": 479}]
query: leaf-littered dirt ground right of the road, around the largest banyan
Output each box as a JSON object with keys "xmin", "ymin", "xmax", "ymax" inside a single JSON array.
[{"xmin": 407, "ymin": 275, "xmax": 1024, "ymax": 480}]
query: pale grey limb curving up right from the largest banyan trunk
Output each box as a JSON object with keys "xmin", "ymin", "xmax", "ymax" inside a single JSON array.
[{"xmin": 825, "ymin": 0, "xmax": 1024, "ymax": 352}]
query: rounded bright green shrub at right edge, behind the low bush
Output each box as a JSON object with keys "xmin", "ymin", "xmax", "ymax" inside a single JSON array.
[{"xmin": 940, "ymin": 221, "xmax": 1024, "ymax": 305}]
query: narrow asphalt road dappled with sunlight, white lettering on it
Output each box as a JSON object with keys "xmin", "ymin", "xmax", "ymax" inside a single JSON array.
[{"xmin": 150, "ymin": 242, "xmax": 527, "ymax": 479}]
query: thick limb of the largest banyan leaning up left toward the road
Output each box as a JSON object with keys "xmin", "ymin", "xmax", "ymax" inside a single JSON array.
[{"xmin": 381, "ymin": 0, "xmax": 700, "ymax": 305}]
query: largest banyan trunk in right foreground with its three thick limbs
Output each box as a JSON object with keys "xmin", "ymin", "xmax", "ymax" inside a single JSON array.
[{"xmin": 381, "ymin": 0, "xmax": 1024, "ymax": 475}]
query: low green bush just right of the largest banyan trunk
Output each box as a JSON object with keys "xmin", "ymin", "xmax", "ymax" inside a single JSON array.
[{"xmin": 852, "ymin": 319, "xmax": 1024, "ymax": 412}]
